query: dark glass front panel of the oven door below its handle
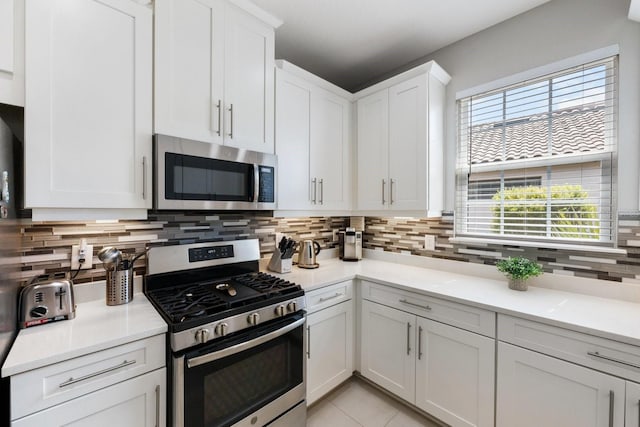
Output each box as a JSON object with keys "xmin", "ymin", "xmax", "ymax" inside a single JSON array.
[{"xmin": 184, "ymin": 326, "xmax": 304, "ymax": 427}]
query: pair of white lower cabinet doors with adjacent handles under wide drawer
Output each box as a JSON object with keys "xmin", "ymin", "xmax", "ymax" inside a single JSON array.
[{"xmin": 360, "ymin": 294, "xmax": 495, "ymax": 426}]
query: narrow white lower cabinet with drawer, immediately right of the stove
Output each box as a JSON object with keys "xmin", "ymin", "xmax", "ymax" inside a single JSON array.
[{"xmin": 306, "ymin": 281, "xmax": 354, "ymax": 405}]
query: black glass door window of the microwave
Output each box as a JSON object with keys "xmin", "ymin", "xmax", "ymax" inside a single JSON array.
[{"xmin": 165, "ymin": 153, "xmax": 254, "ymax": 202}]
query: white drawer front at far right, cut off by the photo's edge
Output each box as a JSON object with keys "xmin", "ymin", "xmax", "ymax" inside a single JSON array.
[{"xmin": 498, "ymin": 314, "xmax": 640, "ymax": 382}]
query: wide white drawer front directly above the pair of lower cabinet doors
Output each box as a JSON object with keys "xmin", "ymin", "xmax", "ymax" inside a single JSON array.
[{"xmin": 362, "ymin": 280, "xmax": 496, "ymax": 338}]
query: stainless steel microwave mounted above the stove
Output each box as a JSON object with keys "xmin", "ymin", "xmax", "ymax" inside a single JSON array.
[{"xmin": 153, "ymin": 135, "xmax": 277, "ymax": 210}]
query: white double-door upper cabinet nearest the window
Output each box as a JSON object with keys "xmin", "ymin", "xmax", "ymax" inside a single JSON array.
[{"xmin": 355, "ymin": 61, "xmax": 450, "ymax": 217}]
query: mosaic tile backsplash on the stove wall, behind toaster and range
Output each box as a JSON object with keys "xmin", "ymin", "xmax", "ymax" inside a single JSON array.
[{"xmin": 15, "ymin": 212, "xmax": 349, "ymax": 283}]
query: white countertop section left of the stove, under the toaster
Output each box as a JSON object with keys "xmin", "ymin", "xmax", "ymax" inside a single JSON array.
[{"xmin": 2, "ymin": 293, "xmax": 167, "ymax": 377}]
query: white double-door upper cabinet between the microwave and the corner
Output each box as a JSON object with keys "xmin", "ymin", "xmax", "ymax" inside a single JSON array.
[{"xmin": 276, "ymin": 61, "xmax": 352, "ymax": 212}]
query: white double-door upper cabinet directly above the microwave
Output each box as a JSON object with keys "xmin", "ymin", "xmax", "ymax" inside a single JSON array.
[{"xmin": 155, "ymin": 0, "xmax": 280, "ymax": 153}]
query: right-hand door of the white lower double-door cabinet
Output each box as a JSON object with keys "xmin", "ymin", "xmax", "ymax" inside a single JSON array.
[{"xmin": 416, "ymin": 317, "xmax": 495, "ymax": 427}]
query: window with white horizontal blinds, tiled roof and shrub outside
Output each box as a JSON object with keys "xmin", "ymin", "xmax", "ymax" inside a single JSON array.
[{"xmin": 455, "ymin": 57, "xmax": 617, "ymax": 245}]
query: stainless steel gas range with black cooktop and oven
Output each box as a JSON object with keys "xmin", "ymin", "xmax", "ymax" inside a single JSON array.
[{"xmin": 144, "ymin": 240, "xmax": 306, "ymax": 427}]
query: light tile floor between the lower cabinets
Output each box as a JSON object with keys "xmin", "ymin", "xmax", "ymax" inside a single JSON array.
[{"xmin": 307, "ymin": 377, "xmax": 438, "ymax": 427}]
